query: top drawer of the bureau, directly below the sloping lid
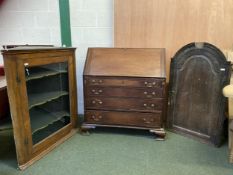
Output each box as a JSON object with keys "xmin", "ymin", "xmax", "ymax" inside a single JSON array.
[{"xmin": 84, "ymin": 76, "xmax": 166, "ymax": 89}]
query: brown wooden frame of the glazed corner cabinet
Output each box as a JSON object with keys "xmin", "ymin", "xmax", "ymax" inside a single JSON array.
[{"xmin": 2, "ymin": 47, "xmax": 77, "ymax": 169}]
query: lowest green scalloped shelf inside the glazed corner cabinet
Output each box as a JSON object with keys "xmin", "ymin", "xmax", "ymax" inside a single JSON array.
[{"xmin": 30, "ymin": 108, "xmax": 70, "ymax": 134}]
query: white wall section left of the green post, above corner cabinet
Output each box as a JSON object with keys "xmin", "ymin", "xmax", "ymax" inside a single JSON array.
[{"xmin": 0, "ymin": 0, "xmax": 61, "ymax": 64}]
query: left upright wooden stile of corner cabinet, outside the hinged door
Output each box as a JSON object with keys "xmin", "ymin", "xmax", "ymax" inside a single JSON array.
[{"xmin": 4, "ymin": 55, "xmax": 28, "ymax": 164}]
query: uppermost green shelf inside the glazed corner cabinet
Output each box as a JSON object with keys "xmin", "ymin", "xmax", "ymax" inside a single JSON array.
[{"xmin": 26, "ymin": 68, "xmax": 67, "ymax": 81}]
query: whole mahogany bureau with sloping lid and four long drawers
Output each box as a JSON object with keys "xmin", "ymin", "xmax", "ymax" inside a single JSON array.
[{"xmin": 82, "ymin": 48, "xmax": 166, "ymax": 139}]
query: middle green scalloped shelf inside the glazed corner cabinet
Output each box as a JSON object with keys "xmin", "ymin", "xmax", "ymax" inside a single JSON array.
[{"xmin": 28, "ymin": 91, "xmax": 69, "ymax": 109}]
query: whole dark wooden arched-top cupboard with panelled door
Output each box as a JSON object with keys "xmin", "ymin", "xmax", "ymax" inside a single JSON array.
[{"xmin": 168, "ymin": 43, "xmax": 230, "ymax": 146}]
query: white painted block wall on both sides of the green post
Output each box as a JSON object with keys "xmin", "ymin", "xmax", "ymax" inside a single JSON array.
[{"xmin": 0, "ymin": 0, "xmax": 113, "ymax": 114}]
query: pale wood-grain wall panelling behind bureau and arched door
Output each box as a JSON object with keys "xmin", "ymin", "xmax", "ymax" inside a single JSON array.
[{"xmin": 114, "ymin": 0, "xmax": 233, "ymax": 75}]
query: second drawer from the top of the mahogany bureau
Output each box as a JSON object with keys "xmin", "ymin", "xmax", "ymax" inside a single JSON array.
[{"xmin": 85, "ymin": 86, "xmax": 164, "ymax": 98}]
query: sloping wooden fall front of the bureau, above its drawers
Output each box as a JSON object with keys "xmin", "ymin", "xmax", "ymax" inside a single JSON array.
[{"xmin": 84, "ymin": 48, "xmax": 165, "ymax": 77}]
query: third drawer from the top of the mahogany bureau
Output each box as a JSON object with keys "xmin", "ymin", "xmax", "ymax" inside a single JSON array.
[{"xmin": 85, "ymin": 97, "xmax": 164, "ymax": 112}]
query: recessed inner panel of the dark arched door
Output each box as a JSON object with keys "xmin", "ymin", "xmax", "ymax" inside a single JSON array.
[{"xmin": 174, "ymin": 58, "xmax": 220, "ymax": 136}]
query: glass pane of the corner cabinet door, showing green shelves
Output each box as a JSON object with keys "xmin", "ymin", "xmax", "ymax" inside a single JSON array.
[{"xmin": 24, "ymin": 62, "xmax": 70, "ymax": 144}]
